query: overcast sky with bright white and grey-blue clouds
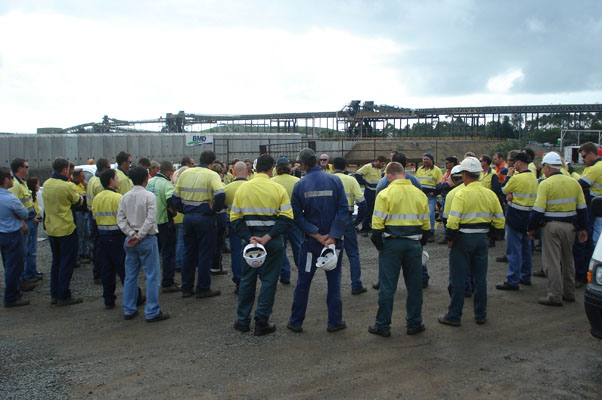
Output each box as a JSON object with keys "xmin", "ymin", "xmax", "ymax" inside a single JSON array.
[{"xmin": 0, "ymin": 0, "xmax": 602, "ymax": 132}]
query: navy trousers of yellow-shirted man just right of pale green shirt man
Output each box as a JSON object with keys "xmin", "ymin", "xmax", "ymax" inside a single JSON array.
[{"xmin": 181, "ymin": 214, "xmax": 217, "ymax": 293}]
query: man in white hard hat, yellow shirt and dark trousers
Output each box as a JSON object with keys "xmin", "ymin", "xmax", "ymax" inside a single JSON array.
[{"xmin": 439, "ymin": 157, "xmax": 504, "ymax": 326}]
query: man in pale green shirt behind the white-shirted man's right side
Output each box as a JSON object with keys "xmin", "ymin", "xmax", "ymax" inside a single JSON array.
[{"xmin": 146, "ymin": 161, "xmax": 180, "ymax": 293}]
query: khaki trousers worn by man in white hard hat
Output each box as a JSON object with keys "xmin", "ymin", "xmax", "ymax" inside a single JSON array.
[{"xmin": 542, "ymin": 221, "xmax": 575, "ymax": 301}]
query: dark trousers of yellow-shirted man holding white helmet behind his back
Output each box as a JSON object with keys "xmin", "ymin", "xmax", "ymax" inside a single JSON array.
[{"xmin": 237, "ymin": 233, "xmax": 283, "ymax": 326}]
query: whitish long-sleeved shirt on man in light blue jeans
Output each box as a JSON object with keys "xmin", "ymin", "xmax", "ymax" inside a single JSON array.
[{"xmin": 117, "ymin": 186, "xmax": 158, "ymax": 240}]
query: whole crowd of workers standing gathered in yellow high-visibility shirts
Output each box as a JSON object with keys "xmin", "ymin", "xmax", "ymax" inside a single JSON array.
[{"xmin": 0, "ymin": 143, "xmax": 602, "ymax": 337}]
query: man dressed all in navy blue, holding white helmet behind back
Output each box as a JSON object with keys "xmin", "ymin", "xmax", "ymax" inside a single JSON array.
[{"xmin": 287, "ymin": 149, "xmax": 346, "ymax": 332}]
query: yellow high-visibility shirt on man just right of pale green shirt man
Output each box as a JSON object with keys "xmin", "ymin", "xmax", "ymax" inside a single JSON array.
[{"xmin": 173, "ymin": 167, "xmax": 225, "ymax": 214}]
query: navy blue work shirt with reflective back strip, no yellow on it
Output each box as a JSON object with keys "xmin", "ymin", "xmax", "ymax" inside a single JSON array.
[{"xmin": 291, "ymin": 166, "xmax": 349, "ymax": 240}]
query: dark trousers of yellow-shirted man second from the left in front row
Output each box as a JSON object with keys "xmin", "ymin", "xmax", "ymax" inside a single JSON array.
[{"xmin": 48, "ymin": 229, "xmax": 78, "ymax": 300}]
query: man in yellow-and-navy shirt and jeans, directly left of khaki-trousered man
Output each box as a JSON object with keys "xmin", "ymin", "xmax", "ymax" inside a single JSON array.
[{"xmin": 495, "ymin": 153, "xmax": 538, "ymax": 290}]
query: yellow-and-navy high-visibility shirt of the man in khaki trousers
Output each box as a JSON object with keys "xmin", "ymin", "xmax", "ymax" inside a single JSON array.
[{"xmin": 533, "ymin": 173, "xmax": 587, "ymax": 221}]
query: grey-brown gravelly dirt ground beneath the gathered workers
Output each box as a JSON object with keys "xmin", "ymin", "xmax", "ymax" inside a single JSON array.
[{"xmin": 0, "ymin": 228, "xmax": 602, "ymax": 399}]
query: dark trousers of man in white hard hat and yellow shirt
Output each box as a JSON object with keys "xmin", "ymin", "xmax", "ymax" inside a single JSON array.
[{"xmin": 446, "ymin": 233, "xmax": 489, "ymax": 322}]
